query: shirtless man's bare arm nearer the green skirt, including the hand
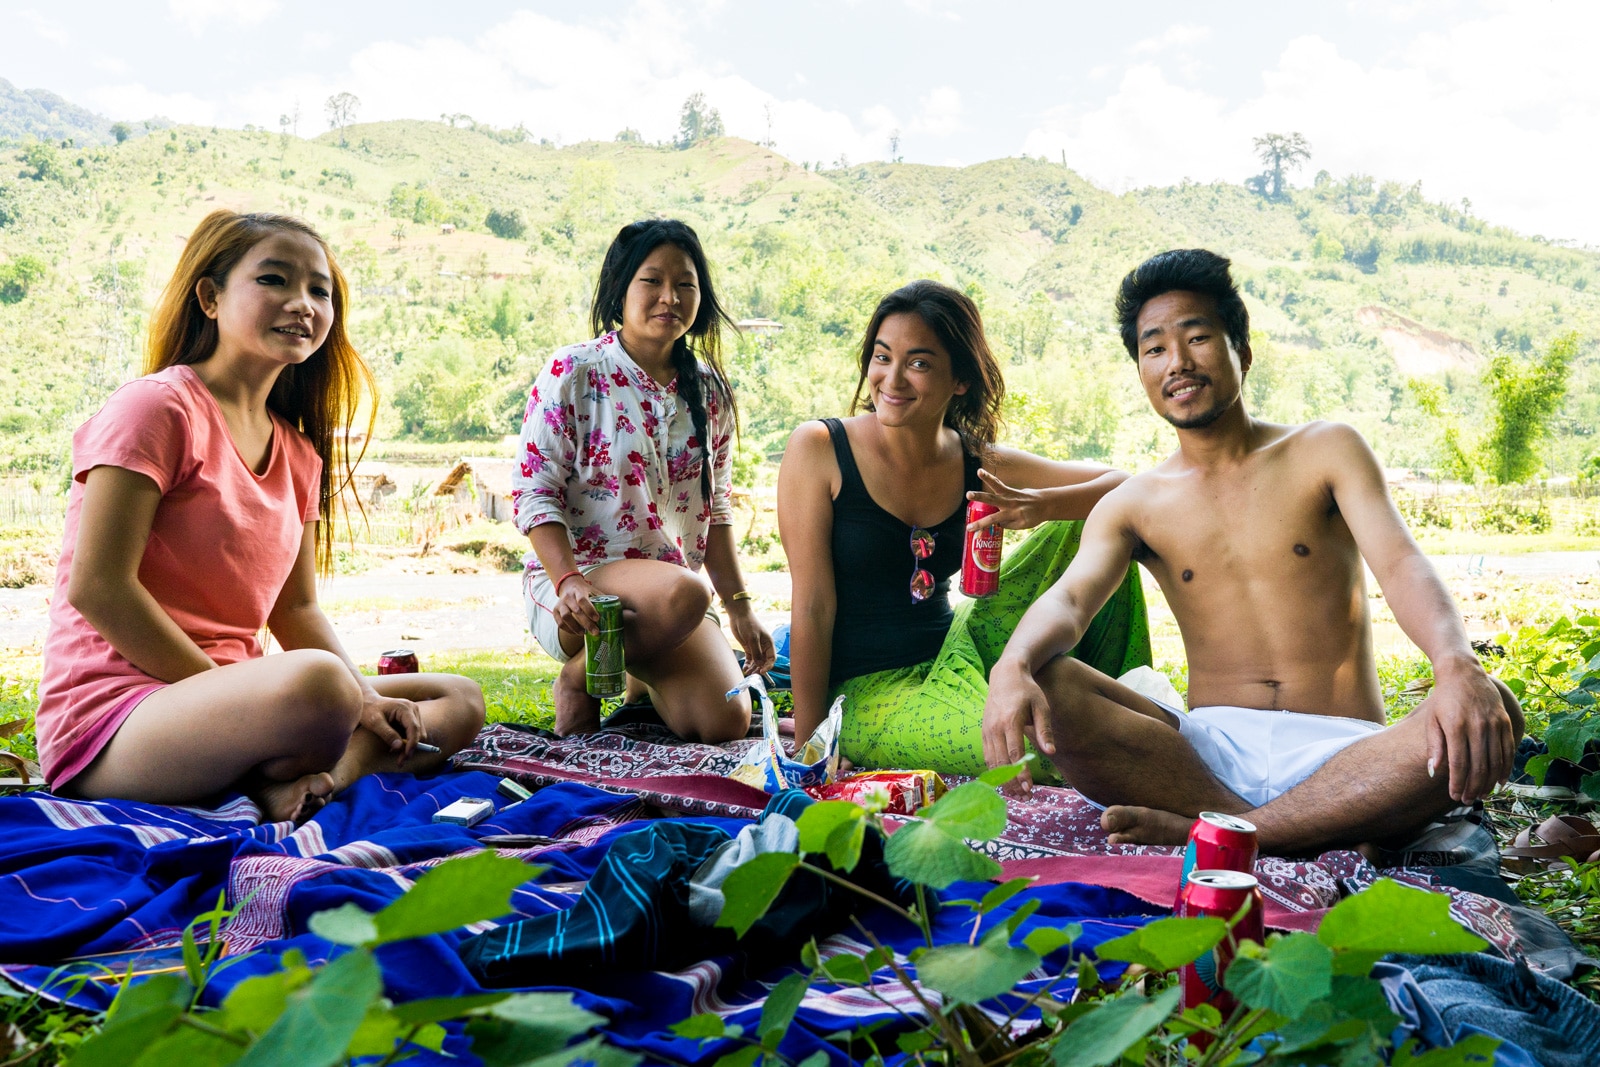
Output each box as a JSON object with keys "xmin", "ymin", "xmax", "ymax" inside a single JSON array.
[{"xmin": 984, "ymin": 482, "xmax": 1136, "ymax": 787}]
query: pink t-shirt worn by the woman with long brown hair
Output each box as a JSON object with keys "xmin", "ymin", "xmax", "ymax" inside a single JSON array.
[{"xmin": 35, "ymin": 366, "xmax": 322, "ymax": 785}]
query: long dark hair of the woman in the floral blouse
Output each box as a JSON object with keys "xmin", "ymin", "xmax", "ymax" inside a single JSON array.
[{"xmin": 589, "ymin": 219, "xmax": 739, "ymax": 501}]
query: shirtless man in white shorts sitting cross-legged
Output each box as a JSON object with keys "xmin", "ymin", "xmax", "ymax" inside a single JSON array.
[{"xmin": 984, "ymin": 250, "xmax": 1522, "ymax": 853}]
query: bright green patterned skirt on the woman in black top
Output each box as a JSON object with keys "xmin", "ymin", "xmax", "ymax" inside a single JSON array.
[{"xmin": 835, "ymin": 522, "xmax": 1150, "ymax": 779}]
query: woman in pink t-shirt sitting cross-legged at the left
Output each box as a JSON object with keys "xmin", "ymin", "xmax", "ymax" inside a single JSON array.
[{"xmin": 37, "ymin": 211, "xmax": 483, "ymax": 821}]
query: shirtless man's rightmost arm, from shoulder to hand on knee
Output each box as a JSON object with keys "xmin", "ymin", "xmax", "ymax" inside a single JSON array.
[{"xmin": 1310, "ymin": 424, "xmax": 1517, "ymax": 803}]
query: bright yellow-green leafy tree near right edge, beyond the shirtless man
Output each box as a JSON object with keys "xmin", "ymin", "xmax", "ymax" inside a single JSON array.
[{"xmin": 1480, "ymin": 333, "xmax": 1578, "ymax": 485}]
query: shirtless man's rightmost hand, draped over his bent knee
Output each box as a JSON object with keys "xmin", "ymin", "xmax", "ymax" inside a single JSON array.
[{"xmin": 1416, "ymin": 659, "xmax": 1517, "ymax": 805}]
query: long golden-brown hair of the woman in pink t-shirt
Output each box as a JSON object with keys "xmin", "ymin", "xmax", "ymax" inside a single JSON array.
[{"xmin": 144, "ymin": 211, "xmax": 378, "ymax": 574}]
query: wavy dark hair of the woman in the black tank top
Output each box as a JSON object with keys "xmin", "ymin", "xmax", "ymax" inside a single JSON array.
[{"xmin": 850, "ymin": 278, "xmax": 1005, "ymax": 456}]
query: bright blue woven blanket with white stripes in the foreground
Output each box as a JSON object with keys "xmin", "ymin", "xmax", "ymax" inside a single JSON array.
[{"xmin": 0, "ymin": 771, "xmax": 1163, "ymax": 1064}]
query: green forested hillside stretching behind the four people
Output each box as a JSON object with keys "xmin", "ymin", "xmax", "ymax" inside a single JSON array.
[{"xmin": 0, "ymin": 122, "xmax": 1600, "ymax": 477}]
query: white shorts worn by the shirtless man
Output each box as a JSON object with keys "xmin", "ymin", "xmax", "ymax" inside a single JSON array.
[{"xmin": 1157, "ymin": 701, "xmax": 1382, "ymax": 806}]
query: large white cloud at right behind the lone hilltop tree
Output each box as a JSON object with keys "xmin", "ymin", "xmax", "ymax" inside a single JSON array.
[{"xmin": 1022, "ymin": 0, "xmax": 1600, "ymax": 243}]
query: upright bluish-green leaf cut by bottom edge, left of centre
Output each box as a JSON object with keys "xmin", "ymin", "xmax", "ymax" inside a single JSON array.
[{"xmin": 238, "ymin": 949, "xmax": 384, "ymax": 1067}]
